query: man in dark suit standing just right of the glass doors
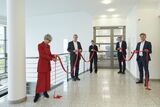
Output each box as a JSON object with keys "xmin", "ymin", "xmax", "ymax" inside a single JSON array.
[{"xmin": 116, "ymin": 36, "xmax": 127, "ymax": 74}]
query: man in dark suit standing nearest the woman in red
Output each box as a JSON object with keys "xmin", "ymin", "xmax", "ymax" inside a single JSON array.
[{"xmin": 67, "ymin": 34, "xmax": 82, "ymax": 81}]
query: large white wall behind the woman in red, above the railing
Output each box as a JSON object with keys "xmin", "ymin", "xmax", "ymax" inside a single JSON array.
[{"xmin": 26, "ymin": 12, "xmax": 93, "ymax": 56}]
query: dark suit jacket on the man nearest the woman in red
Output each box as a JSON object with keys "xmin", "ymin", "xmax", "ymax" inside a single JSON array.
[{"xmin": 67, "ymin": 41, "xmax": 82, "ymax": 58}]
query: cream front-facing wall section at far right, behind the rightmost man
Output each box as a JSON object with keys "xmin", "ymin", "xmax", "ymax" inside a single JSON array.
[{"xmin": 138, "ymin": 7, "xmax": 160, "ymax": 79}]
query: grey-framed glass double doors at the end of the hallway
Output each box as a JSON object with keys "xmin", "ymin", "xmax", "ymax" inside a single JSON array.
[{"xmin": 93, "ymin": 26, "xmax": 126, "ymax": 69}]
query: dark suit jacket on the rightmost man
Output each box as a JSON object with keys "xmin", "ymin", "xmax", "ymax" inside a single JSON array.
[{"xmin": 136, "ymin": 41, "xmax": 152, "ymax": 61}]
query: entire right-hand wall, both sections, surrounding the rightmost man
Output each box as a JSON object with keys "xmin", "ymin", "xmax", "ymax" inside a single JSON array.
[{"xmin": 126, "ymin": 5, "xmax": 160, "ymax": 79}]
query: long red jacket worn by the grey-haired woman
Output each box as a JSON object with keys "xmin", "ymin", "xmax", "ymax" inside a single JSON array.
[{"xmin": 37, "ymin": 42, "xmax": 54, "ymax": 72}]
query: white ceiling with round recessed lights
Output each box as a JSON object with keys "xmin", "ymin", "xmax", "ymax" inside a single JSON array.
[{"xmin": 0, "ymin": 0, "xmax": 160, "ymax": 17}]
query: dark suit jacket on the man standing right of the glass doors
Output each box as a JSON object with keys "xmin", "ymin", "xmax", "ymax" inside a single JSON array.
[{"xmin": 116, "ymin": 41, "xmax": 127, "ymax": 55}]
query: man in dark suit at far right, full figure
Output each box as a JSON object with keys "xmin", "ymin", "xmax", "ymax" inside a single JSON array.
[{"xmin": 136, "ymin": 33, "xmax": 152, "ymax": 84}]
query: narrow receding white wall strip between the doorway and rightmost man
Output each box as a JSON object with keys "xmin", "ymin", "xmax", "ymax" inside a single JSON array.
[{"xmin": 126, "ymin": 7, "xmax": 139, "ymax": 78}]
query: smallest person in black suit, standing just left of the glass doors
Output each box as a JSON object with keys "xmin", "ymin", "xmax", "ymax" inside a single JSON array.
[{"xmin": 89, "ymin": 40, "xmax": 98, "ymax": 73}]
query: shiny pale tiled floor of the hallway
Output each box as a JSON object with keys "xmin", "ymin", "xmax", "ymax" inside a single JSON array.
[{"xmin": 0, "ymin": 69, "xmax": 160, "ymax": 107}]
